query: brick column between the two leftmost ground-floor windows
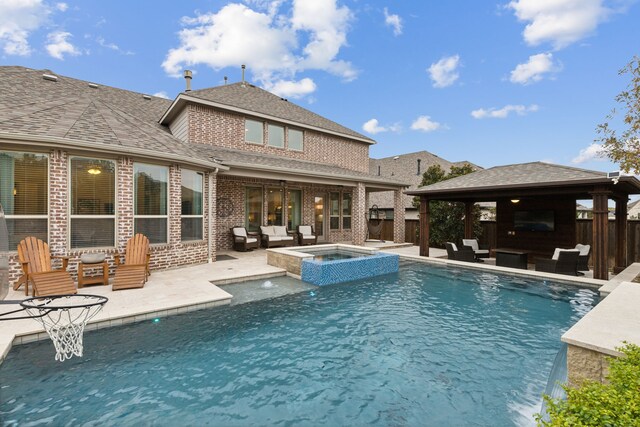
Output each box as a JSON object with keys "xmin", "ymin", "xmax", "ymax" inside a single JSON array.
[{"xmin": 48, "ymin": 150, "xmax": 69, "ymax": 255}]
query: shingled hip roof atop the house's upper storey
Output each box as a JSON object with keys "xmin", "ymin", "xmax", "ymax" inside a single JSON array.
[{"xmin": 160, "ymin": 82, "xmax": 375, "ymax": 144}]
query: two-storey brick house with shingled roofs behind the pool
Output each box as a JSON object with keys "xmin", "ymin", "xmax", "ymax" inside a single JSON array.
[{"xmin": 0, "ymin": 67, "xmax": 404, "ymax": 280}]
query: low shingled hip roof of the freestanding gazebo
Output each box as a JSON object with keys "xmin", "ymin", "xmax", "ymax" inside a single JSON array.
[{"xmin": 406, "ymin": 162, "xmax": 640, "ymax": 201}]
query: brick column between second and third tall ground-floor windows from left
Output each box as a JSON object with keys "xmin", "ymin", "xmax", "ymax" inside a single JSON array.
[{"xmin": 116, "ymin": 157, "xmax": 133, "ymax": 252}]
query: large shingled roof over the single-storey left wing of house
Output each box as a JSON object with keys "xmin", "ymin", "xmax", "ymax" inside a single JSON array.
[{"xmin": 0, "ymin": 67, "xmax": 222, "ymax": 169}]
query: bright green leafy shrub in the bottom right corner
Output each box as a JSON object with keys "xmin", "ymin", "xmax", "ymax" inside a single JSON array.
[{"xmin": 536, "ymin": 343, "xmax": 640, "ymax": 427}]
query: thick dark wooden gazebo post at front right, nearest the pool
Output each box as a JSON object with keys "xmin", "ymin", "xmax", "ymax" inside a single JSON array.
[{"xmin": 591, "ymin": 187, "xmax": 611, "ymax": 280}]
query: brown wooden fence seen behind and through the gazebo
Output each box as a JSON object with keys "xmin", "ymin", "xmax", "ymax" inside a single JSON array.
[{"xmin": 382, "ymin": 219, "xmax": 640, "ymax": 266}]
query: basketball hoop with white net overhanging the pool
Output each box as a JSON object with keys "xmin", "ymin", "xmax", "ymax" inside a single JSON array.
[{"xmin": 0, "ymin": 294, "xmax": 108, "ymax": 362}]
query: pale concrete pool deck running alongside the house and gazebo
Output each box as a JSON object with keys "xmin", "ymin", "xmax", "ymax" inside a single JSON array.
[{"xmin": 0, "ymin": 243, "xmax": 640, "ymax": 376}]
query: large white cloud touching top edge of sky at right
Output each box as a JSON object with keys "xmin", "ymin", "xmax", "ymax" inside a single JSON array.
[{"xmin": 507, "ymin": 0, "xmax": 613, "ymax": 49}]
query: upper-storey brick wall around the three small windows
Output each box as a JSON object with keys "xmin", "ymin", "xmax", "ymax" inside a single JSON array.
[{"xmin": 187, "ymin": 105, "xmax": 369, "ymax": 173}]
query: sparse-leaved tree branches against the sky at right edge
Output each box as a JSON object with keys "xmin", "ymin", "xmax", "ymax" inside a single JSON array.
[{"xmin": 596, "ymin": 56, "xmax": 640, "ymax": 174}]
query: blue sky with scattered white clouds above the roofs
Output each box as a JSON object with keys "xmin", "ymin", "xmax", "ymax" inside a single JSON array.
[{"xmin": 0, "ymin": 0, "xmax": 640, "ymax": 176}]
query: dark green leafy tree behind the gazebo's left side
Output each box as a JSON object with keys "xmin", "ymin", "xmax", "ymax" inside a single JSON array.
[{"xmin": 413, "ymin": 163, "xmax": 482, "ymax": 248}]
